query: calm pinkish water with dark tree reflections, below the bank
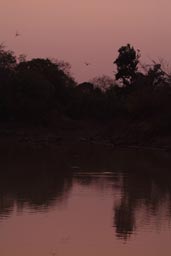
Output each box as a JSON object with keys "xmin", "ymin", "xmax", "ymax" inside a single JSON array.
[{"xmin": 0, "ymin": 148, "xmax": 171, "ymax": 256}]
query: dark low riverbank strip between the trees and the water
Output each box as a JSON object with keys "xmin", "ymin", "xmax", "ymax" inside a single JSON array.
[{"xmin": 0, "ymin": 118, "xmax": 171, "ymax": 151}]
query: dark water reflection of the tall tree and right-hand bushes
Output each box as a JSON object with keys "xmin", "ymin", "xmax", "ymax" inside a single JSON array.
[{"xmin": 113, "ymin": 173, "xmax": 171, "ymax": 240}]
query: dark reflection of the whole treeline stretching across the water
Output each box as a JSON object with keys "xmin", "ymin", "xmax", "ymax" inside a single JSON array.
[{"xmin": 0, "ymin": 148, "xmax": 171, "ymax": 244}]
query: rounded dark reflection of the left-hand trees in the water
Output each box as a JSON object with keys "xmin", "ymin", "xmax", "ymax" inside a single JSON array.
[{"xmin": 0, "ymin": 171, "xmax": 72, "ymax": 218}]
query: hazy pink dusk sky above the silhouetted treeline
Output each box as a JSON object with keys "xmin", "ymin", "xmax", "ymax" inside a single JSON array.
[{"xmin": 0, "ymin": 0, "xmax": 171, "ymax": 82}]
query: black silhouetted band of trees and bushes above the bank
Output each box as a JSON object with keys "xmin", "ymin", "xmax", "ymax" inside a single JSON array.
[{"xmin": 0, "ymin": 44, "xmax": 171, "ymax": 147}]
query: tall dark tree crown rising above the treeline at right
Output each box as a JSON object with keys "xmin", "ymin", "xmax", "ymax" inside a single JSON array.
[{"xmin": 114, "ymin": 44, "xmax": 140, "ymax": 86}]
